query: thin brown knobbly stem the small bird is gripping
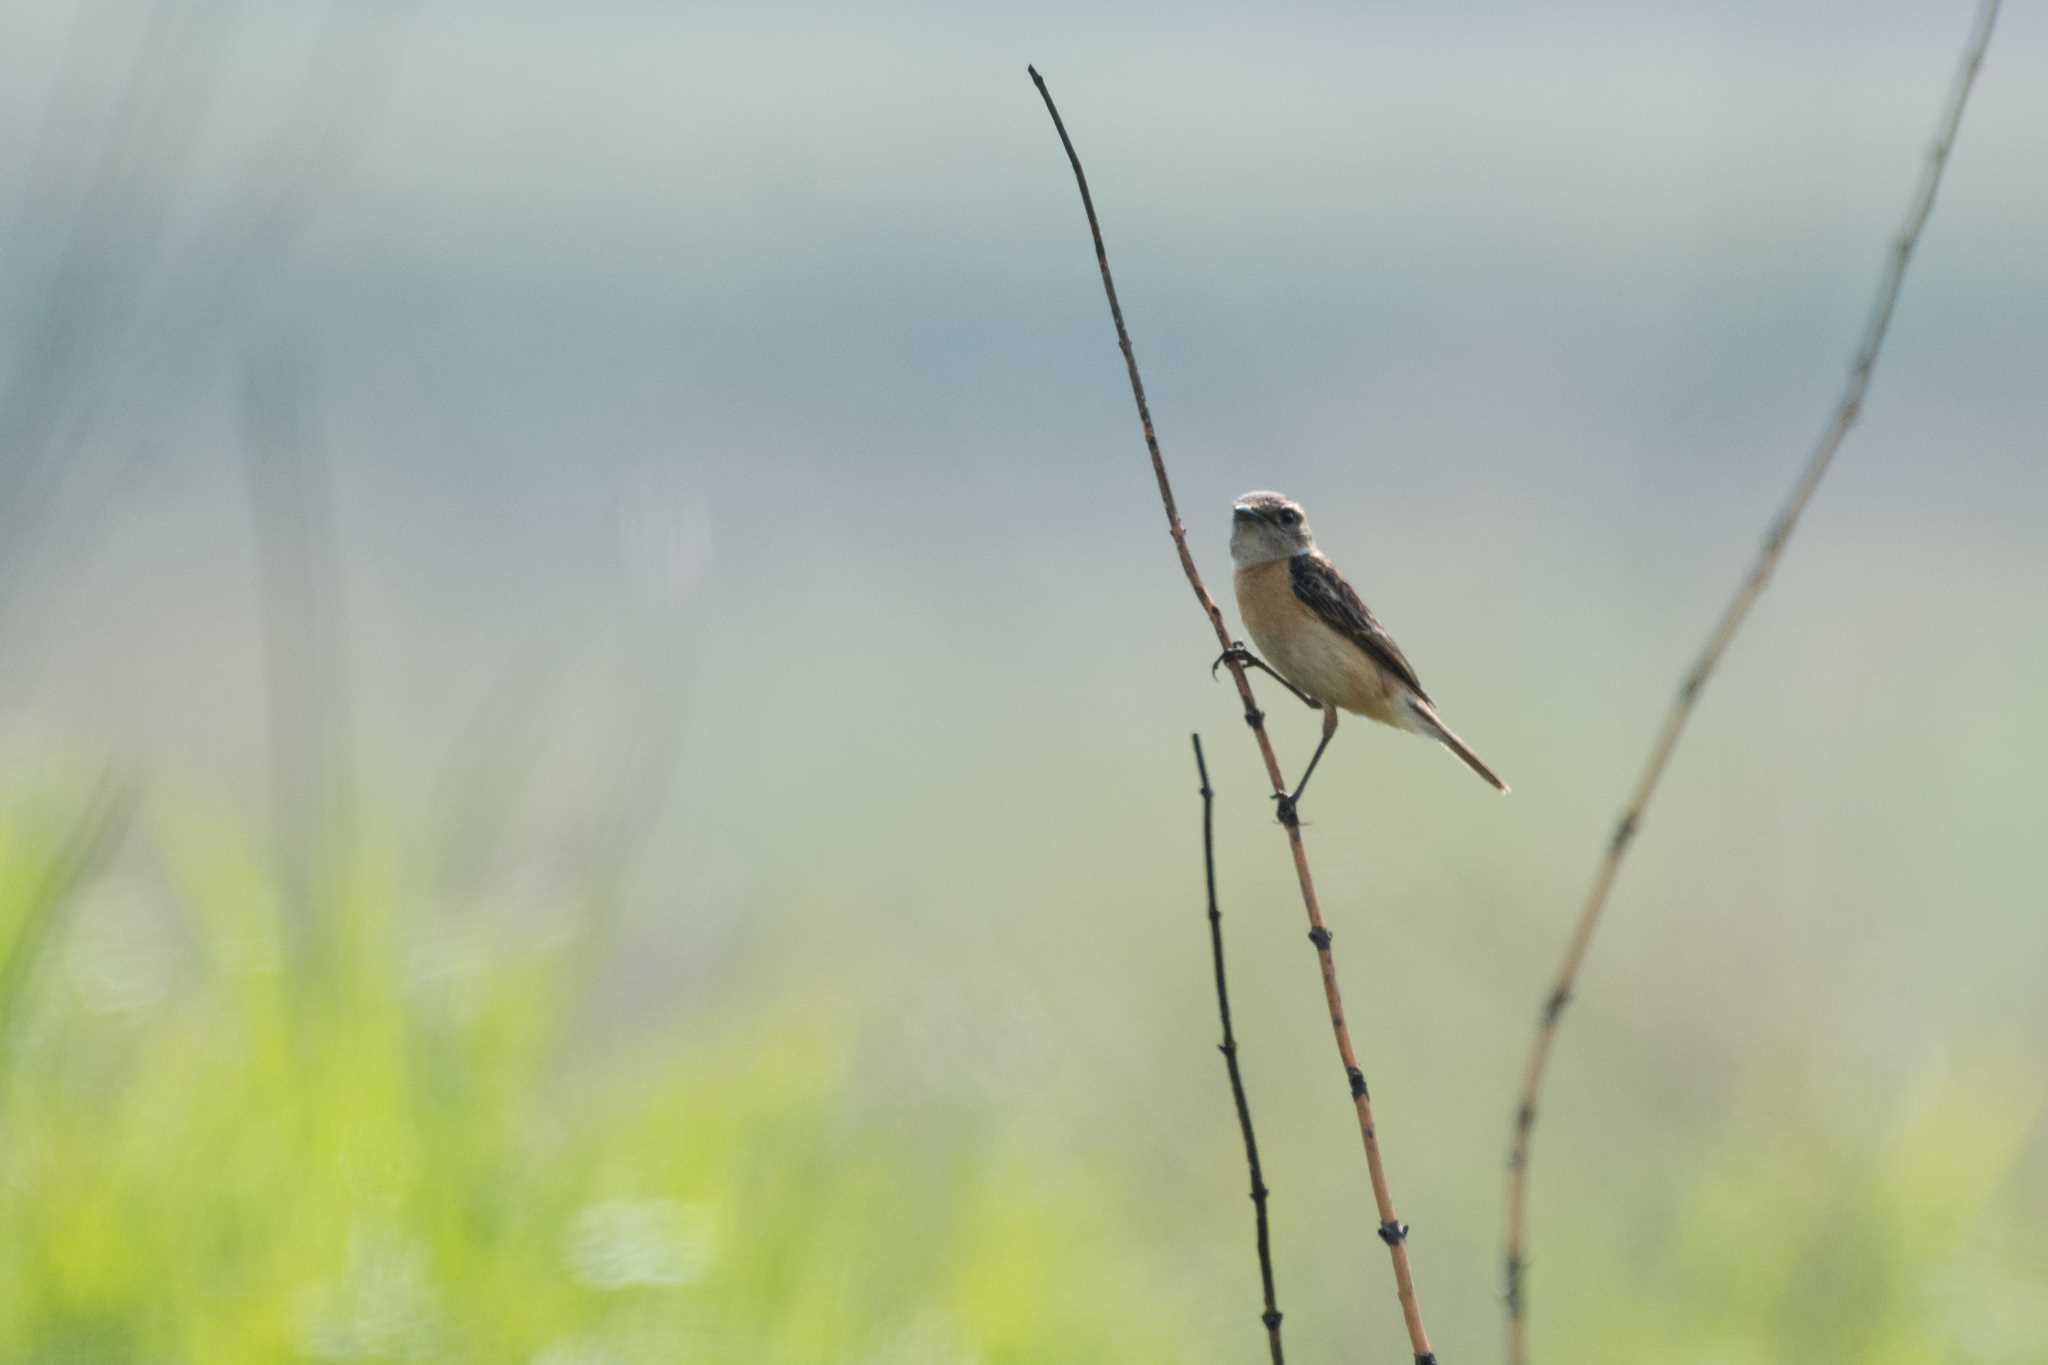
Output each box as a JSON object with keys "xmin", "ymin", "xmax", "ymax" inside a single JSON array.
[{"xmin": 1030, "ymin": 68, "xmax": 1436, "ymax": 1365}]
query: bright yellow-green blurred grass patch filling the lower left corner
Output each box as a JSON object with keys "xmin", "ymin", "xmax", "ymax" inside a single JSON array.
[{"xmin": 0, "ymin": 785, "xmax": 1186, "ymax": 1365}]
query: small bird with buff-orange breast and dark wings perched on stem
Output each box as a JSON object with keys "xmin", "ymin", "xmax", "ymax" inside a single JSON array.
[{"xmin": 1219, "ymin": 493, "xmax": 1507, "ymax": 819}]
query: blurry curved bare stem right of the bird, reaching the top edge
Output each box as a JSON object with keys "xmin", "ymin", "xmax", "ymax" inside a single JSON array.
[{"xmin": 1505, "ymin": 0, "xmax": 1999, "ymax": 1365}]
